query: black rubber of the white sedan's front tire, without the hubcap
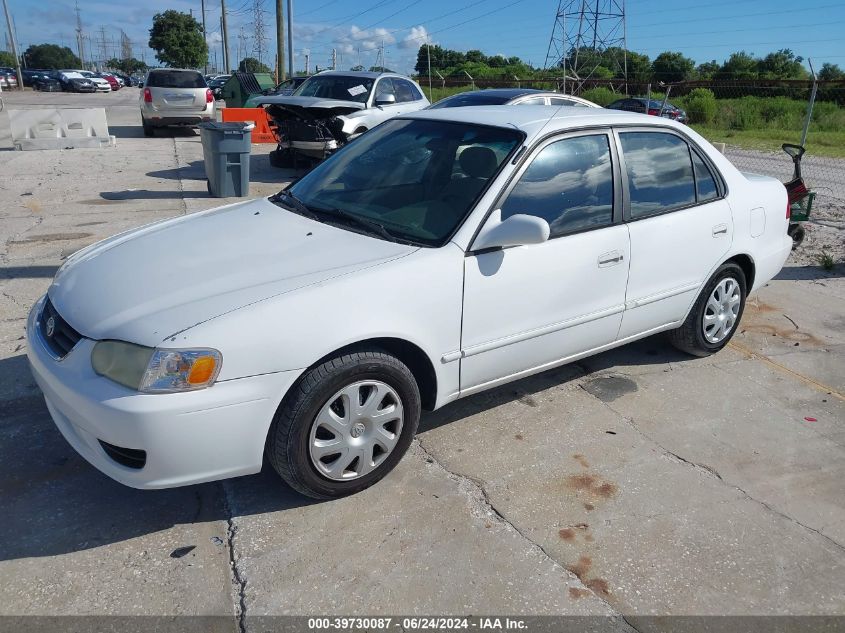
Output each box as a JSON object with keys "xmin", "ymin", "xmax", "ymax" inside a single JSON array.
[{"xmin": 266, "ymin": 350, "xmax": 421, "ymax": 499}]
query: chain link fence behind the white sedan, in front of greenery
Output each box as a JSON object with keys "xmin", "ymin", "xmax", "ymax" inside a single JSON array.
[{"xmin": 426, "ymin": 77, "xmax": 845, "ymax": 222}]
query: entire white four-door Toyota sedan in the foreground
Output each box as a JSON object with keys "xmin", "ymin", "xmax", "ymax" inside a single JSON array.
[{"xmin": 27, "ymin": 106, "xmax": 792, "ymax": 498}]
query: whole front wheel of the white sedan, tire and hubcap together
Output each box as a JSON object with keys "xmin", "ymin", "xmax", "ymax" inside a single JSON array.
[{"xmin": 266, "ymin": 350, "xmax": 421, "ymax": 499}]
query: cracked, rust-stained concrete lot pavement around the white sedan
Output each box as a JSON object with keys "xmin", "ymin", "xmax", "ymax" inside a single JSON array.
[{"xmin": 0, "ymin": 88, "xmax": 845, "ymax": 631}]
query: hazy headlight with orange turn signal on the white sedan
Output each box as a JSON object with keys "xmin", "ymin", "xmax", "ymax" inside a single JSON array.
[{"xmin": 91, "ymin": 341, "xmax": 223, "ymax": 393}]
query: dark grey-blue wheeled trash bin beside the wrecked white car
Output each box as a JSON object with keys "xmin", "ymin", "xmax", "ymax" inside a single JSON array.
[{"xmin": 199, "ymin": 121, "xmax": 255, "ymax": 198}]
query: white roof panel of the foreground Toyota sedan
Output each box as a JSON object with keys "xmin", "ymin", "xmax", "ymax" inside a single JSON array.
[{"xmin": 400, "ymin": 105, "xmax": 684, "ymax": 138}]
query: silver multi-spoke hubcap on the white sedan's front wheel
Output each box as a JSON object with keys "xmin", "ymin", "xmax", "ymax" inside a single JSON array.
[{"xmin": 308, "ymin": 380, "xmax": 404, "ymax": 481}]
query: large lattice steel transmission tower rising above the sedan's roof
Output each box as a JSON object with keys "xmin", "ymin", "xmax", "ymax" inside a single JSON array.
[{"xmin": 543, "ymin": 0, "xmax": 628, "ymax": 91}]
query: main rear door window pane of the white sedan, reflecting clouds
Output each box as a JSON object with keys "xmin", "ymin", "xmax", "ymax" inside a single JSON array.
[{"xmin": 619, "ymin": 132, "xmax": 695, "ymax": 220}]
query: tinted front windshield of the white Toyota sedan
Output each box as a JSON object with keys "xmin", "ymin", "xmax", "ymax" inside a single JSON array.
[{"xmin": 288, "ymin": 119, "xmax": 524, "ymax": 246}]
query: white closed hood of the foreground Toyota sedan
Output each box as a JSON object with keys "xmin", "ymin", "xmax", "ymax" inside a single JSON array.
[{"xmin": 48, "ymin": 198, "xmax": 416, "ymax": 347}]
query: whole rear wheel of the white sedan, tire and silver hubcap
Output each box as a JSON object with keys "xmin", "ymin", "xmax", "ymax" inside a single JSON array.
[{"xmin": 669, "ymin": 262, "xmax": 746, "ymax": 356}]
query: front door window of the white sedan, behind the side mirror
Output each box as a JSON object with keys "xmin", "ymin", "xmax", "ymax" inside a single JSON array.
[{"xmin": 502, "ymin": 134, "xmax": 613, "ymax": 237}]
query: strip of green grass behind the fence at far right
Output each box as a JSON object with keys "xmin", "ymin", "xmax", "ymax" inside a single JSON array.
[{"xmin": 691, "ymin": 124, "xmax": 845, "ymax": 158}]
